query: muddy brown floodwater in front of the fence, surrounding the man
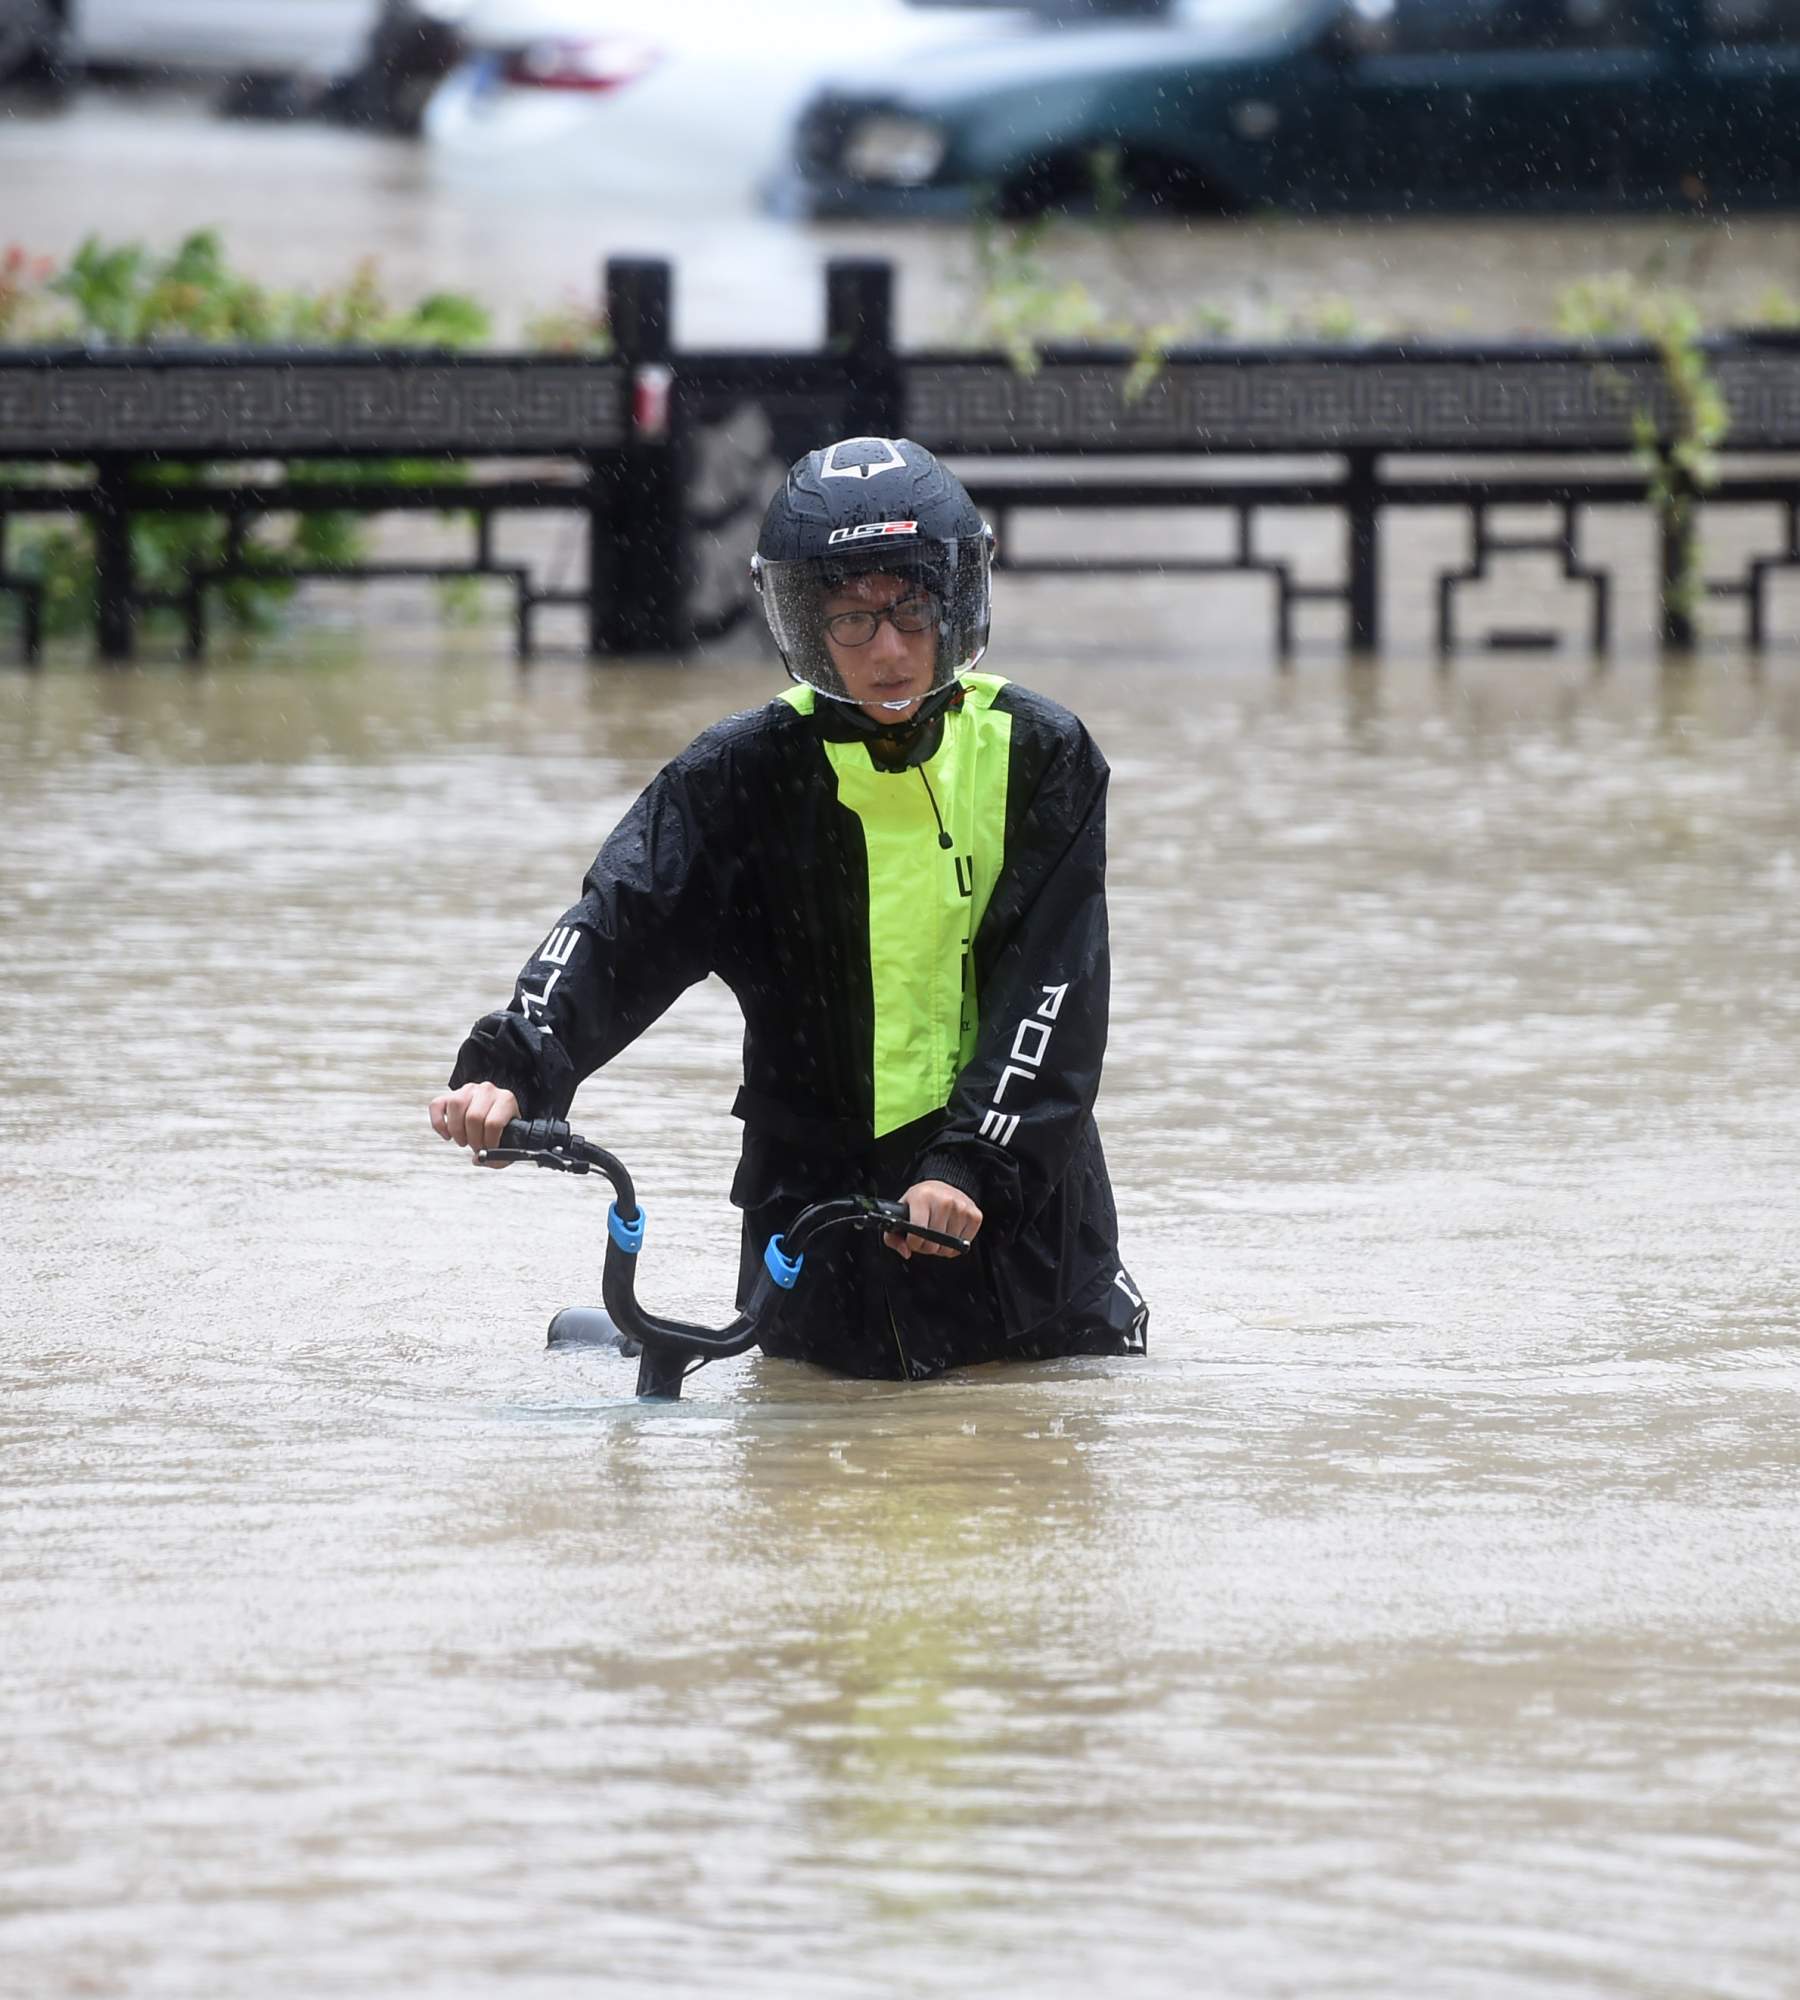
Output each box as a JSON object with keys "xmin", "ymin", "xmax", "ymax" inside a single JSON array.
[{"xmin": 0, "ymin": 628, "xmax": 1800, "ymax": 2000}]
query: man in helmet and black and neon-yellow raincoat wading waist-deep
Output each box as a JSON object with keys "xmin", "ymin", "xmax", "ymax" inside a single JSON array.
[{"xmin": 430, "ymin": 438, "xmax": 1148, "ymax": 1378}]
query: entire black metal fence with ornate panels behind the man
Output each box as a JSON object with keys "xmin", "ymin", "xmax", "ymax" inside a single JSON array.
[{"xmin": 0, "ymin": 260, "xmax": 1800, "ymax": 660}]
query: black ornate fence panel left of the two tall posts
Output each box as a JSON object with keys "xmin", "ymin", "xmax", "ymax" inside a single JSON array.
[{"xmin": 0, "ymin": 350, "xmax": 632, "ymax": 658}]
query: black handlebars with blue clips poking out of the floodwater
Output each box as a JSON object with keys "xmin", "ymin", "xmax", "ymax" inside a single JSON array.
[{"xmin": 482, "ymin": 1118, "xmax": 970, "ymax": 1402}]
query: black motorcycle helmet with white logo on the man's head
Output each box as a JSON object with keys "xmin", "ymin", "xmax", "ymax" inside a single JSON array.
[{"xmin": 750, "ymin": 438, "xmax": 994, "ymax": 722}]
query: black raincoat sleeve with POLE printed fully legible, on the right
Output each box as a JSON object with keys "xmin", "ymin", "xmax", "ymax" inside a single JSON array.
[{"xmin": 914, "ymin": 716, "xmax": 1110, "ymax": 1236}]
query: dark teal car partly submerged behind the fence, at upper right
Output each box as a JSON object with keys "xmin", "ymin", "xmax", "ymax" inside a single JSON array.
[{"xmin": 772, "ymin": 0, "xmax": 1800, "ymax": 216}]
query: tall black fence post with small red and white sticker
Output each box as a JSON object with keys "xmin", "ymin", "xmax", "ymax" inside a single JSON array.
[{"xmin": 588, "ymin": 258, "xmax": 688, "ymax": 654}]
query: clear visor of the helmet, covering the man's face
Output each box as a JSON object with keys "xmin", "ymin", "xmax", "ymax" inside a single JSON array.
[{"xmin": 754, "ymin": 530, "xmax": 994, "ymax": 710}]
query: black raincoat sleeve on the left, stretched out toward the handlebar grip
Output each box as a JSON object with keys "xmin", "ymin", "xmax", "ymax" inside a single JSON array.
[{"xmin": 450, "ymin": 738, "xmax": 728, "ymax": 1118}]
